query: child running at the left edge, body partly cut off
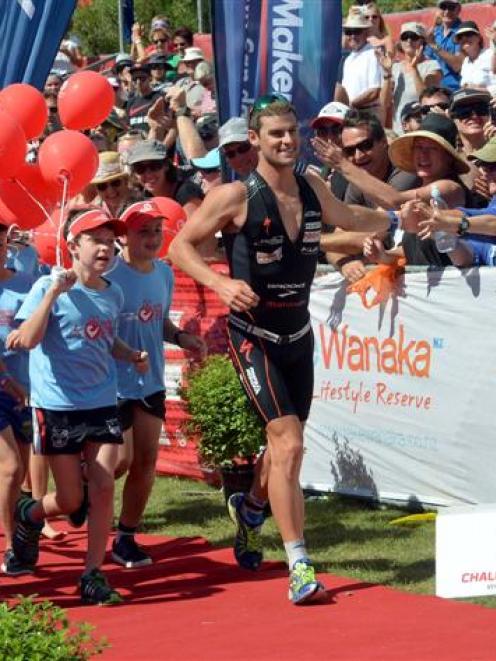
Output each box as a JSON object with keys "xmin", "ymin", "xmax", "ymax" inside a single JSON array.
[{"xmin": 0, "ymin": 224, "xmax": 33, "ymax": 576}]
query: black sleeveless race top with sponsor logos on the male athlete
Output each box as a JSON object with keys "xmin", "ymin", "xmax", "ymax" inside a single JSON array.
[{"xmin": 223, "ymin": 171, "xmax": 322, "ymax": 335}]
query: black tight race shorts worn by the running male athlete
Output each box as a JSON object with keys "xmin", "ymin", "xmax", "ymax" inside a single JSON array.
[{"xmin": 227, "ymin": 325, "xmax": 314, "ymax": 424}]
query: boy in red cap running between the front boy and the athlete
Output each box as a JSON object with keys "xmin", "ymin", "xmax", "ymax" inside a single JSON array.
[{"xmin": 106, "ymin": 201, "xmax": 206, "ymax": 568}]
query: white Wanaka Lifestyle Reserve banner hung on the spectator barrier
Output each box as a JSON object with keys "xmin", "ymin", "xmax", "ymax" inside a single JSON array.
[{"xmin": 301, "ymin": 268, "xmax": 496, "ymax": 505}]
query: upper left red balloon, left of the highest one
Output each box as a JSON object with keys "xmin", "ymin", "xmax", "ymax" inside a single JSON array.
[{"xmin": 0, "ymin": 83, "xmax": 48, "ymax": 140}]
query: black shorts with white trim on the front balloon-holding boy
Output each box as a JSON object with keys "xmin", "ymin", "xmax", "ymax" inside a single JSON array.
[{"xmin": 33, "ymin": 406, "xmax": 123, "ymax": 455}]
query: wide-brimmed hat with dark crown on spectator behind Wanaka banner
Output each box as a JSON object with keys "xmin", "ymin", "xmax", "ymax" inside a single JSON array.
[{"xmin": 389, "ymin": 113, "xmax": 470, "ymax": 174}]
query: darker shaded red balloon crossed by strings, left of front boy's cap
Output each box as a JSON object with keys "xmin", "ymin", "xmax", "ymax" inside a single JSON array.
[{"xmin": 0, "ymin": 163, "xmax": 57, "ymax": 230}]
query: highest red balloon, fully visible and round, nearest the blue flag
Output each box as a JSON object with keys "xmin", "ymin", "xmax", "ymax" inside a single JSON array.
[{"xmin": 58, "ymin": 71, "xmax": 115, "ymax": 131}]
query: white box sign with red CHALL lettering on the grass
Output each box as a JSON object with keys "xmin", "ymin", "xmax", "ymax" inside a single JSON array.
[{"xmin": 436, "ymin": 505, "xmax": 496, "ymax": 597}]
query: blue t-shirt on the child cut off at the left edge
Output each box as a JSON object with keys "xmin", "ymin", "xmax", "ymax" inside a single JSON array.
[{"xmin": 0, "ymin": 272, "xmax": 33, "ymax": 391}]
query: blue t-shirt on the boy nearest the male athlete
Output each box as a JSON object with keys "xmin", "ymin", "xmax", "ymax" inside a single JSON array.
[{"xmin": 105, "ymin": 257, "xmax": 174, "ymax": 399}]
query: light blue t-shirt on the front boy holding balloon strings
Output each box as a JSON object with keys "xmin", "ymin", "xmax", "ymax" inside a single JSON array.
[{"xmin": 16, "ymin": 276, "xmax": 124, "ymax": 411}]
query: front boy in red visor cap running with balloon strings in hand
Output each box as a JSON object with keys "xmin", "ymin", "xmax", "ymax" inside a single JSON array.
[{"xmin": 8, "ymin": 207, "xmax": 148, "ymax": 605}]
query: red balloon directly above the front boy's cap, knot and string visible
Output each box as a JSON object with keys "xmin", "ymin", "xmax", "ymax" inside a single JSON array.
[{"xmin": 38, "ymin": 130, "xmax": 98, "ymax": 197}]
